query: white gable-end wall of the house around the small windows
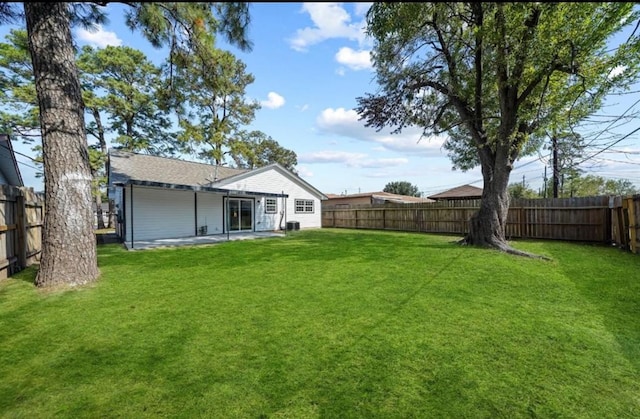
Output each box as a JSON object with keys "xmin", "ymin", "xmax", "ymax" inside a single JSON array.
[{"xmin": 219, "ymin": 169, "xmax": 322, "ymax": 230}]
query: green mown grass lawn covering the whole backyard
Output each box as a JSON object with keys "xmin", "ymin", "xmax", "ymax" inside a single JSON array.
[{"xmin": 0, "ymin": 229, "xmax": 640, "ymax": 419}]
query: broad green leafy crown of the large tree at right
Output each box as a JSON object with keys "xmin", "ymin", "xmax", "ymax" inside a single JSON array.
[{"xmin": 357, "ymin": 2, "xmax": 640, "ymax": 171}]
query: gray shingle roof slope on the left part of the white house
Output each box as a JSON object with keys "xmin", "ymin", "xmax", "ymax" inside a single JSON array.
[{"xmin": 109, "ymin": 150, "xmax": 247, "ymax": 186}]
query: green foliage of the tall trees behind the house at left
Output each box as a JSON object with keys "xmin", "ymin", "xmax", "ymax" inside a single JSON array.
[{"xmin": 0, "ymin": 2, "xmax": 284, "ymax": 184}]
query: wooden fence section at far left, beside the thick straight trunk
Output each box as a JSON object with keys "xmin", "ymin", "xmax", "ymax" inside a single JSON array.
[{"xmin": 0, "ymin": 185, "xmax": 44, "ymax": 279}]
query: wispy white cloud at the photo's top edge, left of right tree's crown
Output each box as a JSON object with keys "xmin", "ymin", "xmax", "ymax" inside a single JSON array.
[{"xmin": 289, "ymin": 3, "xmax": 365, "ymax": 51}]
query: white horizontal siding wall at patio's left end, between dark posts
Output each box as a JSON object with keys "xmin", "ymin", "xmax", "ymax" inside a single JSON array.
[{"xmin": 126, "ymin": 186, "xmax": 196, "ymax": 241}]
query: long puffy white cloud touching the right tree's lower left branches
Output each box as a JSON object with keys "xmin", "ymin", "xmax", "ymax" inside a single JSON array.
[{"xmin": 316, "ymin": 108, "xmax": 445, "ymax": 156}]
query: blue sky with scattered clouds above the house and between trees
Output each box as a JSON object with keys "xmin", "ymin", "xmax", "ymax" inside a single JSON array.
[{"xmin": 5, "ymin": 3, "xmax": 640, "ymax": 196}]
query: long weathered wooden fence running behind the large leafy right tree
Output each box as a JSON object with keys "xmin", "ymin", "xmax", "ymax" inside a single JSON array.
[{"xmin": 322, "ymin": 195, "xmax": 640, "ymax": 253}]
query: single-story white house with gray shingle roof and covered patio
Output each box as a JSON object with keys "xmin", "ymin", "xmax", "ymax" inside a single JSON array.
[{"xmin": 108, "ymin": 150, "xmax": 327, "ymax": 248}]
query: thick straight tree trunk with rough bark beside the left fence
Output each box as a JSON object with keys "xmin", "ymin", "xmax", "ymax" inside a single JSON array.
[{"xmin": 24, "ymin": 3, "xmax": 99, "ymax": 287}]
